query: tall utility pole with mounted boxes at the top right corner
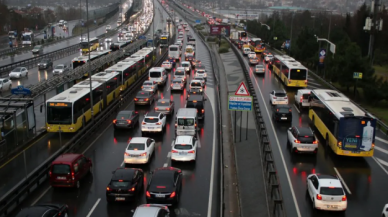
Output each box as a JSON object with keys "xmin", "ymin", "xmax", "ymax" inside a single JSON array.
[{"xmin": 364, "ymin": 0, "xmax": 383, "ymax": 65}]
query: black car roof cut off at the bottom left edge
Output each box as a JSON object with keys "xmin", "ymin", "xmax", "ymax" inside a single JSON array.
[{"xmin": 16, "ymin": 204, "xmax": 69, "ymax": 217}]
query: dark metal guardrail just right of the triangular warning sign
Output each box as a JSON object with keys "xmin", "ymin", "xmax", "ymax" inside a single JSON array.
[{"xmin": 226, "ymin": 39, "xmax": 286, "ymax": 217}]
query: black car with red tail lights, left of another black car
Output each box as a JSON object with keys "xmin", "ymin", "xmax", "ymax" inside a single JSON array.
[{"xmin": 106, "ymin": 168, "xmax": 144, "ymax": 202}]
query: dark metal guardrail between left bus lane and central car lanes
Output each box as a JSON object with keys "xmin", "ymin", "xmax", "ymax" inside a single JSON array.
[{"xmin": 0, "ymin": 10, "xmax": 171, "ymax": 217}]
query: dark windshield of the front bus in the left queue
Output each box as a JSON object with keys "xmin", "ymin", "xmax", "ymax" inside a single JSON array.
[{"xmin": 47, "ymin": 103, "xmax": 72, "ymax": 124}]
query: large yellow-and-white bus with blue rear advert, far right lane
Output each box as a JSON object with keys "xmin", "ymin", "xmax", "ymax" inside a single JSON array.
[{"xmin": 309, "ymin": 89, "xmax": 376, "ymax": 157}]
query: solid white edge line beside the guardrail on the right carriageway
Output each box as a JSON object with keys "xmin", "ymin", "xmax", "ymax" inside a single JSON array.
[{"xmin": 247, "ymin": 54, "xmax": 302, "ymax": 217}]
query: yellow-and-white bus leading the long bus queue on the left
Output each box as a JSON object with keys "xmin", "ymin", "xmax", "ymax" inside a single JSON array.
[{"xmin": 46, "ymin": 80, "xmax": 103, "ymax": 133}]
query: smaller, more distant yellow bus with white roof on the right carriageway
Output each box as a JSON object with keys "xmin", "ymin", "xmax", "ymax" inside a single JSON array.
[{"xmin": 272, "ymin": 55, "xmax": 308, "ymax": 87}]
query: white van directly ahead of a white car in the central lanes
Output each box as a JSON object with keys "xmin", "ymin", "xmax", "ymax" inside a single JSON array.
[{"xmin": 175, "ymin": 108, "xmax": 198, "ymax": 136}]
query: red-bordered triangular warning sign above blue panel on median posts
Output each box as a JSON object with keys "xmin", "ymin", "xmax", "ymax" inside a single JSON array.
[{"xmin": 228, "ymin": 82, "xmax": 252, "ymax": 142}]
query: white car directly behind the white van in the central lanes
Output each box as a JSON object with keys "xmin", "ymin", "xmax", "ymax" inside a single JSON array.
[{"xmin": 171, "ymin": 136, "xmax": 198, "ymax": 161}]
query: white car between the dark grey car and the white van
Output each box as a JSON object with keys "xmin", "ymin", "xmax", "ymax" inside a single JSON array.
[{"xmin": 141, "ymin": 112, "xmax": 167, "ymax": 135}]
